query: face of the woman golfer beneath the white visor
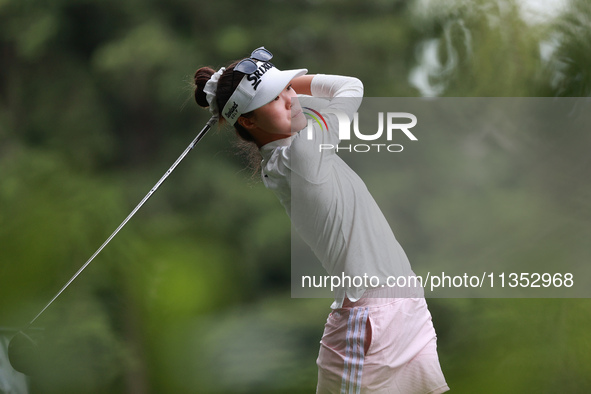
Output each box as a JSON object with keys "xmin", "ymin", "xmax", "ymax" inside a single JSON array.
[{"xmin": 251, "ymin": 85, "xmax": 307, "ymax": 144}]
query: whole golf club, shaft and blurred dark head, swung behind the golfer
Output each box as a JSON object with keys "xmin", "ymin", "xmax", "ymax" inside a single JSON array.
[{"xmin": 8, "ymin": 116, "xmax": 218, "ymax": 374}]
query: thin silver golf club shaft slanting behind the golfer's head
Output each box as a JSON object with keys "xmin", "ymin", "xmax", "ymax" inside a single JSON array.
[{"xmin": 24, "ymin": 116, "xmax": 217, "ymax": 330}]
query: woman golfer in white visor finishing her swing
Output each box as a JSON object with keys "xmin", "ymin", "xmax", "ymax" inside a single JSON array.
[{"xmin": 195, "ymin": 47, "xmax": 449, "ymax": 394}]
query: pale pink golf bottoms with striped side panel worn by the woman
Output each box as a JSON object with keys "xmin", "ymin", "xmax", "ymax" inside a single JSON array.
[{"xmin": 316, "ymin": 290, "xmax": 449, "ymax": 394}]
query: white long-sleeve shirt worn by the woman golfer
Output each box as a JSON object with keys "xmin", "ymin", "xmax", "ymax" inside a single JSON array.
[{"xmin": 260, "ymin": 75, "xmax": 416, "ymax": 309}]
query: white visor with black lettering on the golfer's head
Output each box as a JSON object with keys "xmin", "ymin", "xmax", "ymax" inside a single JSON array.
[{"xmin": 222, "ymin": 61, "xmax": 308, "ymax": 125}]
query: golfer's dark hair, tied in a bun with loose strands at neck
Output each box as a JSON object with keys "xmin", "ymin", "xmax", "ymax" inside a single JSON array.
[{"xmin": 194, "ymin": 61, "xmax": 261, "ymax": 172}]
